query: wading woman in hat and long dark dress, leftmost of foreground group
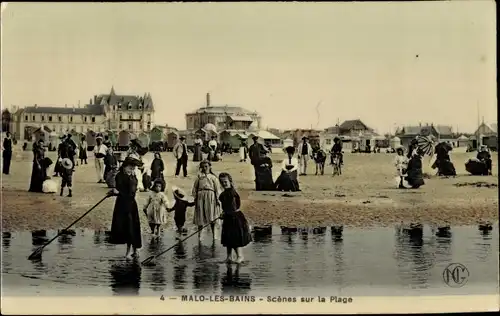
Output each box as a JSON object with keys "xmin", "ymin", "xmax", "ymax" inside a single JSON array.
[{"xmin": 108, "ymin": 157, "xmax": 142, "ymax": 258}]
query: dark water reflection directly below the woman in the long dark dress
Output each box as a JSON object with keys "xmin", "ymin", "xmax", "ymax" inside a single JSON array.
[{"xmin": 109, "ymin": 260, "xmax": 141, "ymax": 295}]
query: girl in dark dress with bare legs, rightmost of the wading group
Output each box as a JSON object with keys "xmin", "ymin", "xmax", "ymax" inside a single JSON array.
[{"xmin": 219, "ymin": 172, "xmax": 252, "ymax": 263}]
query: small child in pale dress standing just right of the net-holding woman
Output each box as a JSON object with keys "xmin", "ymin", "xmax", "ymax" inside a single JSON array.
[{"xmin": 143, "ymin": 180, "xmax": 168, "ymax": 237}]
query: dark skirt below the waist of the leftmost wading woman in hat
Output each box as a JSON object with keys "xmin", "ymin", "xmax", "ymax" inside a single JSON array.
[{"xmin": 110, "ymin": 196, "xmax": 142, "ymax": 248}]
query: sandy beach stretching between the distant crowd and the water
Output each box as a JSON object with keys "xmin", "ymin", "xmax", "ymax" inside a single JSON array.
[{"xmin": 2, "ymin": 152, "xmax": 498, "ymax": 231}]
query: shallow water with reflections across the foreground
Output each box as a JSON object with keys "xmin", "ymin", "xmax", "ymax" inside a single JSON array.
[{"xmin": 2, "ymin": 224, "xmax": 499, "ymax": 296}]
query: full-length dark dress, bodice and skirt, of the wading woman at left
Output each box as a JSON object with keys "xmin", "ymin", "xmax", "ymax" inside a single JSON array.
[{"xmin": 110, "ymin": 170, "xmax": 142, "ymax": 248}]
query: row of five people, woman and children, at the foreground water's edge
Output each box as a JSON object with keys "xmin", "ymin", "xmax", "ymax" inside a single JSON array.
[{"xmin": 108, "ymin": 155, "xmax": 252, "ymax": 263}]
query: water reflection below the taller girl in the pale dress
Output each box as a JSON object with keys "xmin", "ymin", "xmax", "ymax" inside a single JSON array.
[{"xmin": 193, "ymin": 244, "xmax": 220, "ymax": 292}]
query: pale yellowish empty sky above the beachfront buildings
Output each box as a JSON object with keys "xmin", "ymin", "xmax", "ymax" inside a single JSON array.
[{"xmin": 1, "ymin": 0, "xmax": 497, "ymax": 133}]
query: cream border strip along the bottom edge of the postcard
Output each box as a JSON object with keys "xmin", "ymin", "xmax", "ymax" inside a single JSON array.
[{"xmin": 2, "ymin": 295, "xmax": 499, "ymax": 315}]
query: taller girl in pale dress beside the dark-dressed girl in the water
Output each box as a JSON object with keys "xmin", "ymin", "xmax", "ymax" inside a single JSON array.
[{"xmin": 192, "ymin": 160, "xmax": 221, "ymax": 240}]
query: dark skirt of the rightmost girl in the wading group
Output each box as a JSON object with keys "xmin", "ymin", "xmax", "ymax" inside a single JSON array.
[{"xmin": 221, "ymin": 211, "xmax": 252, "ymax": 248}]
